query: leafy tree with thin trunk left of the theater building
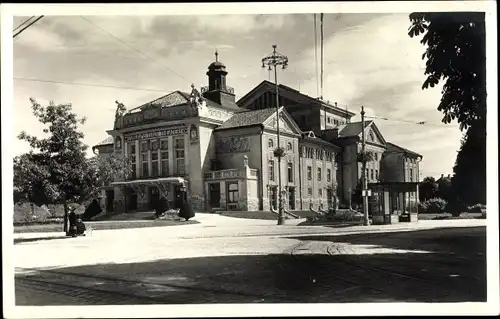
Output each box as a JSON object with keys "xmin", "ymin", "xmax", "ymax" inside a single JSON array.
[{"xmin": 14, "ymin": 99, "xmax": 131, "ymax": 231}]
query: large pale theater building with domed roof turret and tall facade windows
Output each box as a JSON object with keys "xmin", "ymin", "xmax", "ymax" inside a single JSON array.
[{"xmin": 93, "ymin": 55, "xmax": 418, "ymax": 218}]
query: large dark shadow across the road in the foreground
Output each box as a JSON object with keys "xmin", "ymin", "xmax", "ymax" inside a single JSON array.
[{"xmin": 16, "ymin": 227, "xmax": 486, "ymax": 305}]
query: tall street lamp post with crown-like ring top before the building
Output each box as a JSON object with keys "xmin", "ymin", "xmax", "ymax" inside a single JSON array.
[{"xmin": 262, "ymin": 44, "xmax": 288, "ymax": 225}]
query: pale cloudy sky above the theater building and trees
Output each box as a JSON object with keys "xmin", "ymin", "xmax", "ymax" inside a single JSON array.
[{"xmin": 12, "ymin": 13, "xmax": 462, "ymax": 178}]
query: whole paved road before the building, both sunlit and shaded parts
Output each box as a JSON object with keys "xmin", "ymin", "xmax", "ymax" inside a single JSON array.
[{"xmin": 14, "ymin": 216, "xmax": 486, "ymax": 305}]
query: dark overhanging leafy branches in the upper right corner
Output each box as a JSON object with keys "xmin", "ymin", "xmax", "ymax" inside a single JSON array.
[{"xmin": 408, "ymin": 12, "xmax": 486, "ymax": 130}]
